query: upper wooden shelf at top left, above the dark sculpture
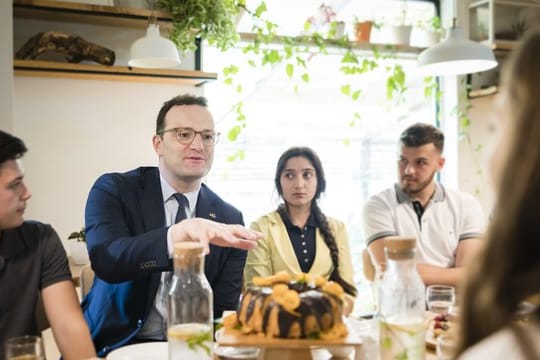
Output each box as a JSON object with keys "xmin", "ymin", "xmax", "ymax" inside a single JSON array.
[{"xmin": 13, "ymin": 0, "xmax": 171, "ymax": 29}]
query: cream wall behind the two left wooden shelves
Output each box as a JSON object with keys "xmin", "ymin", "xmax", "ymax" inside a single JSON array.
[{"xmin": 12, "ymin": 14, "xmax": 203, "ymax": 245}]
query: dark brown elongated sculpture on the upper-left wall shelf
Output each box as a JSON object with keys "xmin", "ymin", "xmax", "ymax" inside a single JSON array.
[{"xmin": 15, "ymin": 31, "xmax": 115, "ymax": 65}]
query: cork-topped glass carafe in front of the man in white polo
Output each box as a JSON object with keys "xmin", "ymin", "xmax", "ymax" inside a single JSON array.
[{"xmin": 379, "ymin": 237, "xmax": 426, "ymax": 360}]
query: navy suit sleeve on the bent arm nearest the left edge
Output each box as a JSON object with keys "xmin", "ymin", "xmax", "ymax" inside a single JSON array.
[{"xmin": 85, "ymin": 174, "xmax": 171, "ymax": 283}]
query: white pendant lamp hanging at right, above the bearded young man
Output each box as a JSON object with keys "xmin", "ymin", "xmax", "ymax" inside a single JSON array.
[{"xmin": 417, "ymin": 18, "xmax": 497, "ymax": 76}]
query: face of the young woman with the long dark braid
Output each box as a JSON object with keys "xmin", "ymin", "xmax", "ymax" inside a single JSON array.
[{"xmin": 279, "ymin": 156, "xmax": 317, "ymax": 207}]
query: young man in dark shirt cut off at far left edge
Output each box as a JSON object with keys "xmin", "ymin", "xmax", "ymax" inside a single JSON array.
[{"xmin": 0, "ymin": 131, "xmax": 96, "ymax": 360}]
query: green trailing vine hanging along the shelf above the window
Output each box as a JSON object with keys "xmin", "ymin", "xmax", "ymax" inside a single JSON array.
[{"xmin": 158, "ymin": 0, "xmax": 434, "ymax": 161}]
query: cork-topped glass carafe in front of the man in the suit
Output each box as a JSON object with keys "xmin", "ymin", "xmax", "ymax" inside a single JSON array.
[{"xmin": 167, "ymin": 241, "xmax": 213, "ymax": 360}]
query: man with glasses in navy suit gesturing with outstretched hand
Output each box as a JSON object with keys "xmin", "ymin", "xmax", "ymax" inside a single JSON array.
[{"xmin": 82, "ymin": 95, "xmax": 261, "ymax": 356}]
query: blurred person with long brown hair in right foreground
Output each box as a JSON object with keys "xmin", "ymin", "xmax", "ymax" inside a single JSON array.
[{"xmin": 458, "ymin": 27, "xmax": 540, "ymax": 359}]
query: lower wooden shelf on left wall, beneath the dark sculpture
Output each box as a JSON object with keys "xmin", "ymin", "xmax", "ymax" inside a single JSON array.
[{"xmin": 13, "ymin": 60, "xmax": 217, "ymax": 86}]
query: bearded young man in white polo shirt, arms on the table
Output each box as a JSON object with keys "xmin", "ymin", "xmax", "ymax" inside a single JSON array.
[{"xmin": 364, "ymin": 123, "xmax": 485, "ymax": 286}]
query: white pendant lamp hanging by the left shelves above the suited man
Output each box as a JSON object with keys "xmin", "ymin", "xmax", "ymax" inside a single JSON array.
[{"xmin": 128, "ymin": 2, "xmax": 180, "ymax": 69}]
